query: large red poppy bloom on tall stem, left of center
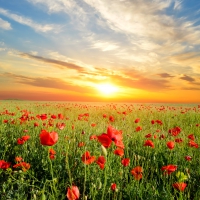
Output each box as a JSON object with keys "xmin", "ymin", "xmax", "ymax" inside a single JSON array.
[{"xmin": 40, "ymin": 130, "xmax": 58, "ymax": 146}]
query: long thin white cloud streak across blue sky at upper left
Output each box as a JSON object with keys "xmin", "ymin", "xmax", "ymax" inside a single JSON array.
[{"xmin": 0, "ymin": 8, "xmax": 61, "ymax": 33}]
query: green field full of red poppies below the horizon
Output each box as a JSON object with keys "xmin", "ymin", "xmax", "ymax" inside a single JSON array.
[{"xmin": 0, "ymin": 101, "xmax": 200, "ymax": 200}]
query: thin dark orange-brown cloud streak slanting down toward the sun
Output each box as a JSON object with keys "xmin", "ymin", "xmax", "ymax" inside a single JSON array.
[{"xmin": 19, "ymin": 53, "xmax": 84, "ymax": 72}]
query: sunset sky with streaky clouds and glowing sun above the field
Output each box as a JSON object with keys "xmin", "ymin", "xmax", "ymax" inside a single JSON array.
[{"xmin": 0, "ymin": 0, "xmax": 200, "ymax": 103}]
